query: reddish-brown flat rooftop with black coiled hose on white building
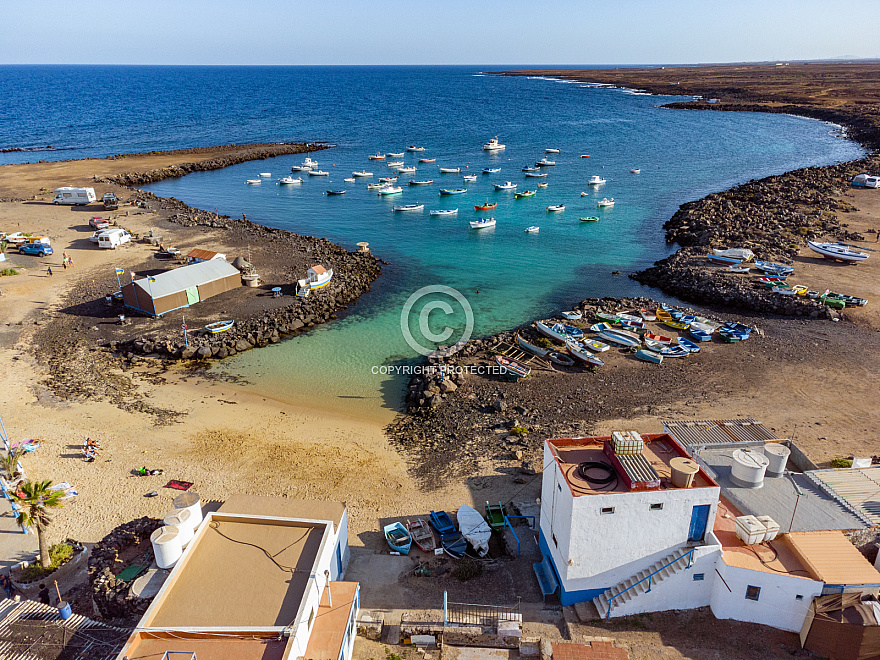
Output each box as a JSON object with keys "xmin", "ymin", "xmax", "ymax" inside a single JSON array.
[{"xmin": 547, "ymin": 433, "xmax": 717, "ymax": 497}]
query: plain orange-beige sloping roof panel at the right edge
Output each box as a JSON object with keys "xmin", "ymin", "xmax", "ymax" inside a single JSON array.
[{"xmin": 785, "ymin": 531, "xmax": 880, "ymax": 585}]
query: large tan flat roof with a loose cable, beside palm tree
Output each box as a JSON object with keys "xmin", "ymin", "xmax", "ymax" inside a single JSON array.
[{"xmin": 141, "ymin": 512, "xmax": 326, "ymax": 629}]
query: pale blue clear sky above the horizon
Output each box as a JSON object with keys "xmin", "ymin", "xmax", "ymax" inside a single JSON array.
[{"xmin": 0, "ymin": 0, "xmax": 880, "ymax": 66}]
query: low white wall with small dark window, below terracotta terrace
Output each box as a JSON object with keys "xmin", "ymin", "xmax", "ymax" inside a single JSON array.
[{"xmin": 707, "ymin": 561, "xmax": 822, "ymax": 632}]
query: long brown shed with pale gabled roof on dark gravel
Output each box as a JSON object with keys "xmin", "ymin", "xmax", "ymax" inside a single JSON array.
[{"xmin": 122, "ymin": 259, "xmax": 241, "ymax": 316}]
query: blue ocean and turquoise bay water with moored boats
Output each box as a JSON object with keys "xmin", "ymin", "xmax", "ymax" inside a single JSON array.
[{"xmin": 0, "ymin": 66, "xmax": 862, "ymax": 419}]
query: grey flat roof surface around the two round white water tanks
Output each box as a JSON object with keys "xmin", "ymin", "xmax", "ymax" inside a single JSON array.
[{"xmin": 696, "ymin": 448, "xmax": 869, "ymax": 532}]
